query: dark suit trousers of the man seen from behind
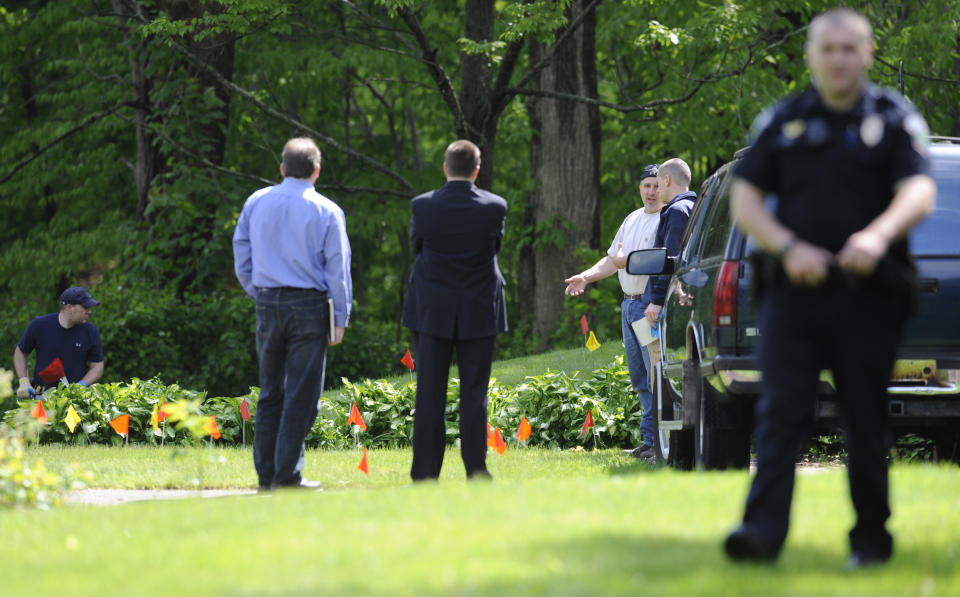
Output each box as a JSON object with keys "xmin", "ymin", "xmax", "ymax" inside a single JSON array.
[{"xmin": 410, "ymin": 333, "xmax": 494, "ymax": 481}]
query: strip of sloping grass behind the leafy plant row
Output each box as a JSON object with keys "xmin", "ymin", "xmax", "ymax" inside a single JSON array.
[{"xmin": 323, "ymin": 336, "xmax": 623, "ymax": 398}]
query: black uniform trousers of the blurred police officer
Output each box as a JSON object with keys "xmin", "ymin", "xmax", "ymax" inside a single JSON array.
[{"xmin": 744, "ymin": 288, "xmax": 907, "ymax": 557}]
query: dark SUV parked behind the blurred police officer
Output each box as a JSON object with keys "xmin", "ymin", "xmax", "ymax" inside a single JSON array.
[{"xmin": 627, "ymin": 137, "xmax": 960, "ymax": 469}]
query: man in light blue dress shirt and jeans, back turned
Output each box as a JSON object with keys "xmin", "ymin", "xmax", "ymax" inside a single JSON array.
[{"xmin": 233, "ymin": 138, "xmax": 353, "ymax": 489}]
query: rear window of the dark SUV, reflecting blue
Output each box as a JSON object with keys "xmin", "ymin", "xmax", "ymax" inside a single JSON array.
[{"xmin": 910, "ymin": 147, "xmax": 960, "ymax": 256}]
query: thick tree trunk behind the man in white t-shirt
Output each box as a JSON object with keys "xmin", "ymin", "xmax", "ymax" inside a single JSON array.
[{"xmin": 518, "ymin": 0, "xmax": 600, "ymax": 350}]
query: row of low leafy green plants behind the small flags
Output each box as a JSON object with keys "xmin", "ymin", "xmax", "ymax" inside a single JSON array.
[{"xmin": 3, "ymin": 356, "xmax": 641, "ymax": 449}]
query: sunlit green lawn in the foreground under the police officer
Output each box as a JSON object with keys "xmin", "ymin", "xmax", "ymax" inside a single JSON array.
[{"xmin": 0, "ymin": 446, "xmax": 960, "ymax": 596}]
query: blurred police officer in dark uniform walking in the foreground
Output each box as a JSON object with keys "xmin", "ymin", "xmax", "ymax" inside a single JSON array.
[{"xmin": 724, "ymin": 9, "xmax": 936, "ymax": 568}]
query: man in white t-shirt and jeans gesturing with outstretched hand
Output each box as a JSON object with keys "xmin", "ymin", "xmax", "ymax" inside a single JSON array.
[{"xmin": 564, "ymin": 164, "xmax": 663, "ymax": 460}]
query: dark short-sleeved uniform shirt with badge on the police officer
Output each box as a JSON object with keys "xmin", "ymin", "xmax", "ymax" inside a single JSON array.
[{"xmin": 734, "ymin": 85, "xmax": 930, "ymax": 270}]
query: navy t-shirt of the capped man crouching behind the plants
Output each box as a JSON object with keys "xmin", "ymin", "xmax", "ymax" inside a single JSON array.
[{"xmin": 18, "ymin": 313, "xmax": 103, "ymax": 387}]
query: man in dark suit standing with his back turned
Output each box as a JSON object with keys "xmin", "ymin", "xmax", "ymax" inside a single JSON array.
[{"xmin": 403, "ymin": 140, "xmax": 507, "ymax": 481}]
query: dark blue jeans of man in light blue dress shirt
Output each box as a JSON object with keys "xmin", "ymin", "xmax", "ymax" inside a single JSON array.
[{"xmin": 253, "ymin": 288, "xmax": 329, "ymax": 488}]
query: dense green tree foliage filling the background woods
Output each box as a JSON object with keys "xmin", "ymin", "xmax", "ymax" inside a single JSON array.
[{"xmin": 0, "ymin": 0, "xmax": 960, "ymax": 392}]
